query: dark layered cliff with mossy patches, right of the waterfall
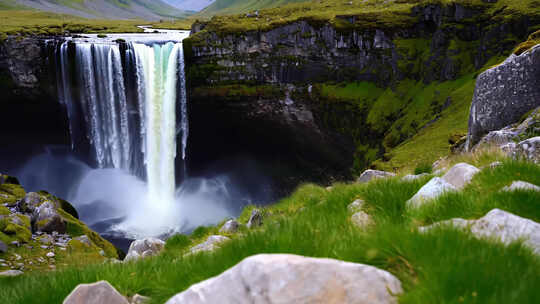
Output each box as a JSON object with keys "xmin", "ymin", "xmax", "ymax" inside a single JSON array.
[{"xmin": 184, "ymin": 4, "xmax": 538, "ymax": 177}]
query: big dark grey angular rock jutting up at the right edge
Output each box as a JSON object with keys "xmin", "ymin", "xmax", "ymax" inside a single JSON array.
[{"xmin": 467, "ymin": 46, "xmax": 540, "ymax": 150}]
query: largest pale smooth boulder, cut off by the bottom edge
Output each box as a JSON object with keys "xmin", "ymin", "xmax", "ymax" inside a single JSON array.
[{"xmin": 167, "ymin": 254, "xmax": 403, "ymax": 304}]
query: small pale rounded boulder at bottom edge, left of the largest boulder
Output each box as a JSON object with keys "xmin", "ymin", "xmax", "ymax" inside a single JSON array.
[{"xmin": 63, "ymin": 281, "xmax": 129, "ymax": 304}]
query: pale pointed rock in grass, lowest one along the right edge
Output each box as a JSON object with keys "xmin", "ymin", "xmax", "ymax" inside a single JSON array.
[{"xmin": 420, "ymin": 209, "xmax": 540, "ymax": 254}]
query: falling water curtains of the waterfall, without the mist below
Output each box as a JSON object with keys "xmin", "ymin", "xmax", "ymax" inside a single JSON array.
[{"xmin": 56, "ymin": 36, "xmax": 188, "ymax": 206}]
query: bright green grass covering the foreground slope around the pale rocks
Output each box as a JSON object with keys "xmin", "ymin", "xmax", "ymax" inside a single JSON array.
[{"xmin": 0, "ymin": 161, "xmax": 540, "ymax": 303}]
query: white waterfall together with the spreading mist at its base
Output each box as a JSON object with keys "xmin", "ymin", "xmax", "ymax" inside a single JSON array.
[{"xmin": 14, "ymin": 31, "xmax": 270, "ymax": 242}]
